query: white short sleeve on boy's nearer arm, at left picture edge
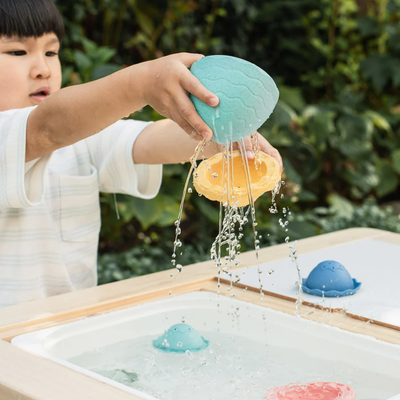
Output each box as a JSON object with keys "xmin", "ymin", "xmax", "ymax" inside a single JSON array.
[{"xmin": 0, "ymin": 107, "xmax": 51, "ymax": 209}]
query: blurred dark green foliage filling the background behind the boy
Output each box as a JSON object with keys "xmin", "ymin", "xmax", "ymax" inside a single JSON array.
[{"xmin": 56, "ymin": 0, "xmax": 400, "ymax": 283}]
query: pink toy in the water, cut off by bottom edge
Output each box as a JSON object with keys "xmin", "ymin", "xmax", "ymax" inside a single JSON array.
[{"xmin": 266, "ymin": 382, "xmax": 356, "ymax": 400}]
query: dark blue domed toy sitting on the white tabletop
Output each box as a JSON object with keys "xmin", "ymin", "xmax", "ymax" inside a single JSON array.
[{"xmin": 303, "ymin": 260, "xmax": 361, "ymax": 297}]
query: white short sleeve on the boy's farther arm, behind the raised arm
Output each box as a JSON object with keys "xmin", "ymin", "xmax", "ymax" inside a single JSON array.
[{"xmin": 85, "ymin": 120, "xmax": 162, "ymax": 199}]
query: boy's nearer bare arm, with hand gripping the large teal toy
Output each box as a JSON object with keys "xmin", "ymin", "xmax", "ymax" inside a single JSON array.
[{"xmin": 25, "ymin": 53, "xmax": 218, "ymax": 161}]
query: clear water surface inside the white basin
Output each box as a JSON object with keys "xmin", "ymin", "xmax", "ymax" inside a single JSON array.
[{"xmin": 68, "ymin": 331, "xmax": 394, "ymax": 400}]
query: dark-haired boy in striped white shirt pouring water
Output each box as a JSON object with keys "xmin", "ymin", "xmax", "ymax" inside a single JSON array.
[{"xmin": 0, "ymin": 0, "xmax": 280, "ymax": 306}]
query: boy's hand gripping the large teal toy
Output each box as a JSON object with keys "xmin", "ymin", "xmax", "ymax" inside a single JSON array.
[{"xmin": 137, "ymin": 53, "xmax": 219, "ymax": 140}]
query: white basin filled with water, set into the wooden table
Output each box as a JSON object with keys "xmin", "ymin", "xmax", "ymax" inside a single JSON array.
[{"xmin": 12, "ymin": 291, "xmax": 400, "ymax": 400}]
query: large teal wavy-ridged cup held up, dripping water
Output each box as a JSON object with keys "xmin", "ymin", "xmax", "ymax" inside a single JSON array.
[{"xmin": 190, "ymin": 56, "xmax": 279, "ymax": 144}]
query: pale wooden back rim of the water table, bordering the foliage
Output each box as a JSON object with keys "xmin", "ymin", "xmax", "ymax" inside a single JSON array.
[{"xmin": 0, "ymin": 228, "xmax": 400, "ymax": 340}]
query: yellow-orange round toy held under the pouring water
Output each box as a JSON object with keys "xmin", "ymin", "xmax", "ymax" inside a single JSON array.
[{"xmin": 193, "ymin": 150, "xmax": 281, "ymax": 207}]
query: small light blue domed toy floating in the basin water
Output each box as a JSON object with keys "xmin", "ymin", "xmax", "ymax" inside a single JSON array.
[{"xmin": 153, "ymin": 324, "xmax": 210, "ymax": 353}]
